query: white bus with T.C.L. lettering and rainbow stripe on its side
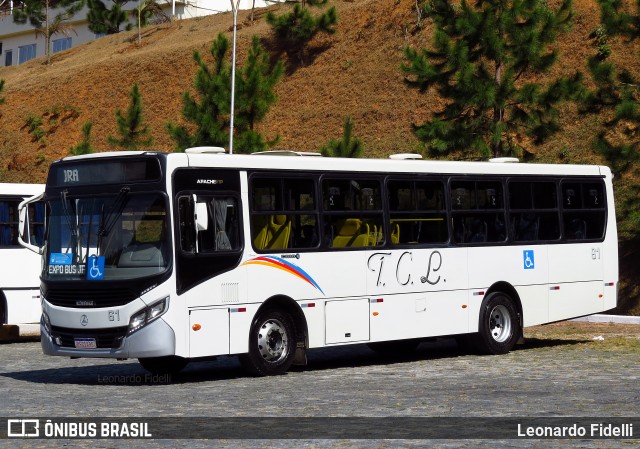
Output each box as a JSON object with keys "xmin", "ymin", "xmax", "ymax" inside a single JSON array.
[{"xmin": 20, "ymin": 148, "xmax": 618, "ymax": 375}]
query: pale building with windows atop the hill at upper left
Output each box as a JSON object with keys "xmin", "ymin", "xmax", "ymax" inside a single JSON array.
[{"xmin": 0, "ymin": 0, "xmax": 275, "ymax": 67}]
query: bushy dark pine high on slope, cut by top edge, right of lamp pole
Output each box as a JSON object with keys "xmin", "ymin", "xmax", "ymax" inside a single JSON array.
[{"xmin": 267, "ymin": 0, "xmax": 338, "ymax": 64}]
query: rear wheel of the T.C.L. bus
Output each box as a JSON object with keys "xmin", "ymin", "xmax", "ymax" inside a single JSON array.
[{"xmin": 478, "ymin": 292, "xmax": 522, "ymax": 354}]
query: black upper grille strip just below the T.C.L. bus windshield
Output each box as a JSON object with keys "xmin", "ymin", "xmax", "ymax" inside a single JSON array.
[{"xmin": 45, "ymin": 288, "xmax": 138, "ymax": 309}]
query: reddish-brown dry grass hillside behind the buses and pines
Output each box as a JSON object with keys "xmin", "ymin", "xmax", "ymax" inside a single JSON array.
[{"xmin": 0, "ymin": 0, "xmax": 640, "ymax": 314}]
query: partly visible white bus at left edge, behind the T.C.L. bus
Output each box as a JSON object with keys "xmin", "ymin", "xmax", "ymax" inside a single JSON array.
[{"xmin": 0, "ymin": 183, "xmax": 44, "ymax": 325}]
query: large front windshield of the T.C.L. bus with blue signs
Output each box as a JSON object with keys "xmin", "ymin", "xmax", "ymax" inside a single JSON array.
[{"xmin": 43, "ymin": 187, "xmax": 171, "ymax": 281}]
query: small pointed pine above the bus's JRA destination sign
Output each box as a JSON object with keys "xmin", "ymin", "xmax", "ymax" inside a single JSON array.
[{"xmin": 107, "ymin": 83, "xmax": 153, "ymax": 151}]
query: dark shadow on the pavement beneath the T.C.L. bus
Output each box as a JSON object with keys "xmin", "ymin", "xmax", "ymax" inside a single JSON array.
[{"xmin": 0, "ymin": 338, "xmax": 585, "ymax": 387}]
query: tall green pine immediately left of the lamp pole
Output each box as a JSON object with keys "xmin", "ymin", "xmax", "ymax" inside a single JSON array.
[{"xmin": 167, "ymin": 33, "xmax": 231, "ymax": 151}]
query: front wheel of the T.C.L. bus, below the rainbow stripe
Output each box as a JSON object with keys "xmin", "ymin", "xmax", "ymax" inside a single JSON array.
[{"xmin": 240, "ymin": 309, "xmax": 296, "ymax": 376}]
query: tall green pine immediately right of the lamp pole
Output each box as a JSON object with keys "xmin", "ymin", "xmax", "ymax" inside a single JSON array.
[{"xmin": 234, "ymin": 36, "xmax": 284, "ymax": 153}]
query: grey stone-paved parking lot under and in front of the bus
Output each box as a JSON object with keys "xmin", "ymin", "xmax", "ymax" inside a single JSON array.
[{"xmin": 0, "ymin": 327, "xmax": 640, "ymax": 448}]
